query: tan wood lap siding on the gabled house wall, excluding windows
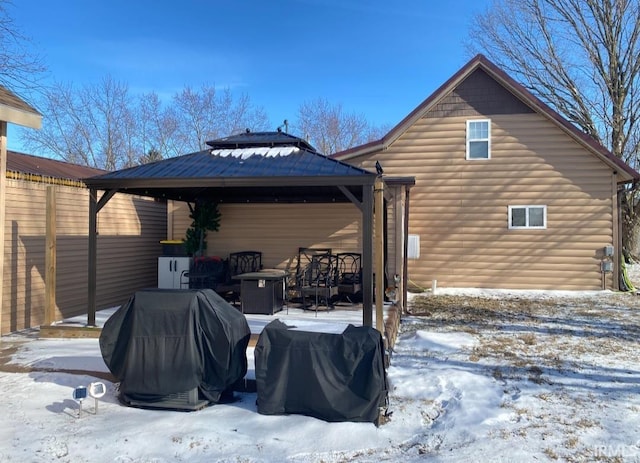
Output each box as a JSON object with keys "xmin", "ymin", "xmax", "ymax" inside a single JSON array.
[{"xmin": 356, "ymin": 113, "xmax": 615, "ymax": 290}]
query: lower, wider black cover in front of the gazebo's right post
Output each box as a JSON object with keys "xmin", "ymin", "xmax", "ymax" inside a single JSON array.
[{"xmin": 254, "ymin": 320, "xmax": 388, "ymax": 422}]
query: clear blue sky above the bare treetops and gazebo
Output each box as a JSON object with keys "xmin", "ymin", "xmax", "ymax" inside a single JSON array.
[{"xmin": 8, "ymin": 0, "xmax": 490, "ymax": 149}]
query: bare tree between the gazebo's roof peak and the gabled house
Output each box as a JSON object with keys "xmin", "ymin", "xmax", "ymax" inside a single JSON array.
[{"xmin": 293, "ymin": 98, "xmax": 384, "ymax": 155}]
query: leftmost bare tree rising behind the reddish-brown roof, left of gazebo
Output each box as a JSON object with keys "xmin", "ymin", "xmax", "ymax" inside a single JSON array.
[{"xmin": 22, "ymin": 77, "xmax": 139, "ymax": 170}]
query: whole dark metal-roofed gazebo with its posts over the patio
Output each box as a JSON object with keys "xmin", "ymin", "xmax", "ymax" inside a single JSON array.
[{"xmin": 84, "ymin": 131, "xmax": 414, "ymax": 334}]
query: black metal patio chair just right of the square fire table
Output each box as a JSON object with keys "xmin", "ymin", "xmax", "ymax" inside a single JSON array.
[{"xmin": 300, "ymin": 253, "xmax": 338, "ymax": 316}]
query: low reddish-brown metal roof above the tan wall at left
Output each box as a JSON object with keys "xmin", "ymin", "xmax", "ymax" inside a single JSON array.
[{"xmin": 7, "ymin": 151, "xmax": 106, "ymax": 181}]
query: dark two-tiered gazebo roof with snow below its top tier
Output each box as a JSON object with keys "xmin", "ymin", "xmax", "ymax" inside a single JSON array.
[{"xmin": 84, "ymin": 132, "xmax": 376, "ymax": 202}]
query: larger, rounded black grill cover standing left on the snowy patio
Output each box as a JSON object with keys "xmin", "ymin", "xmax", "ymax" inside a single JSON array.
[{"xmin": 100, "ymin": 289, "xmax": 251, "ymax": 403}]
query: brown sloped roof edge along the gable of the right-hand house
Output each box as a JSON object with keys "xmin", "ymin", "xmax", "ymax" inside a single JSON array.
[{"xmin": 331, "ymin": 54, "xmax": 640, "ymax": 183}]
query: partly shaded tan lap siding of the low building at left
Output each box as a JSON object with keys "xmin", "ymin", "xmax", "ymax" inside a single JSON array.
[{"xmin": 2, "ymin": 180, "xmax": 166, "ymax": 334}]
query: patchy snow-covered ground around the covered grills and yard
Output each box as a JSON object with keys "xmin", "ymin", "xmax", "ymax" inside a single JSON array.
[{"xmin": 0, "ymin": 276, "xmax": 640, "ymax": 463}]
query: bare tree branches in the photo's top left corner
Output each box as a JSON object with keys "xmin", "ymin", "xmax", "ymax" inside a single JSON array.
[{"xmin": 0, "ymin": 0, "xmax": 46, "ymax": 93}]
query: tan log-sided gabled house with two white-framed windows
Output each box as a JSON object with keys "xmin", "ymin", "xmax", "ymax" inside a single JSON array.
[{"xmin": 333, "ymin": 55, "xmax": 639, "ymax": 290}]
